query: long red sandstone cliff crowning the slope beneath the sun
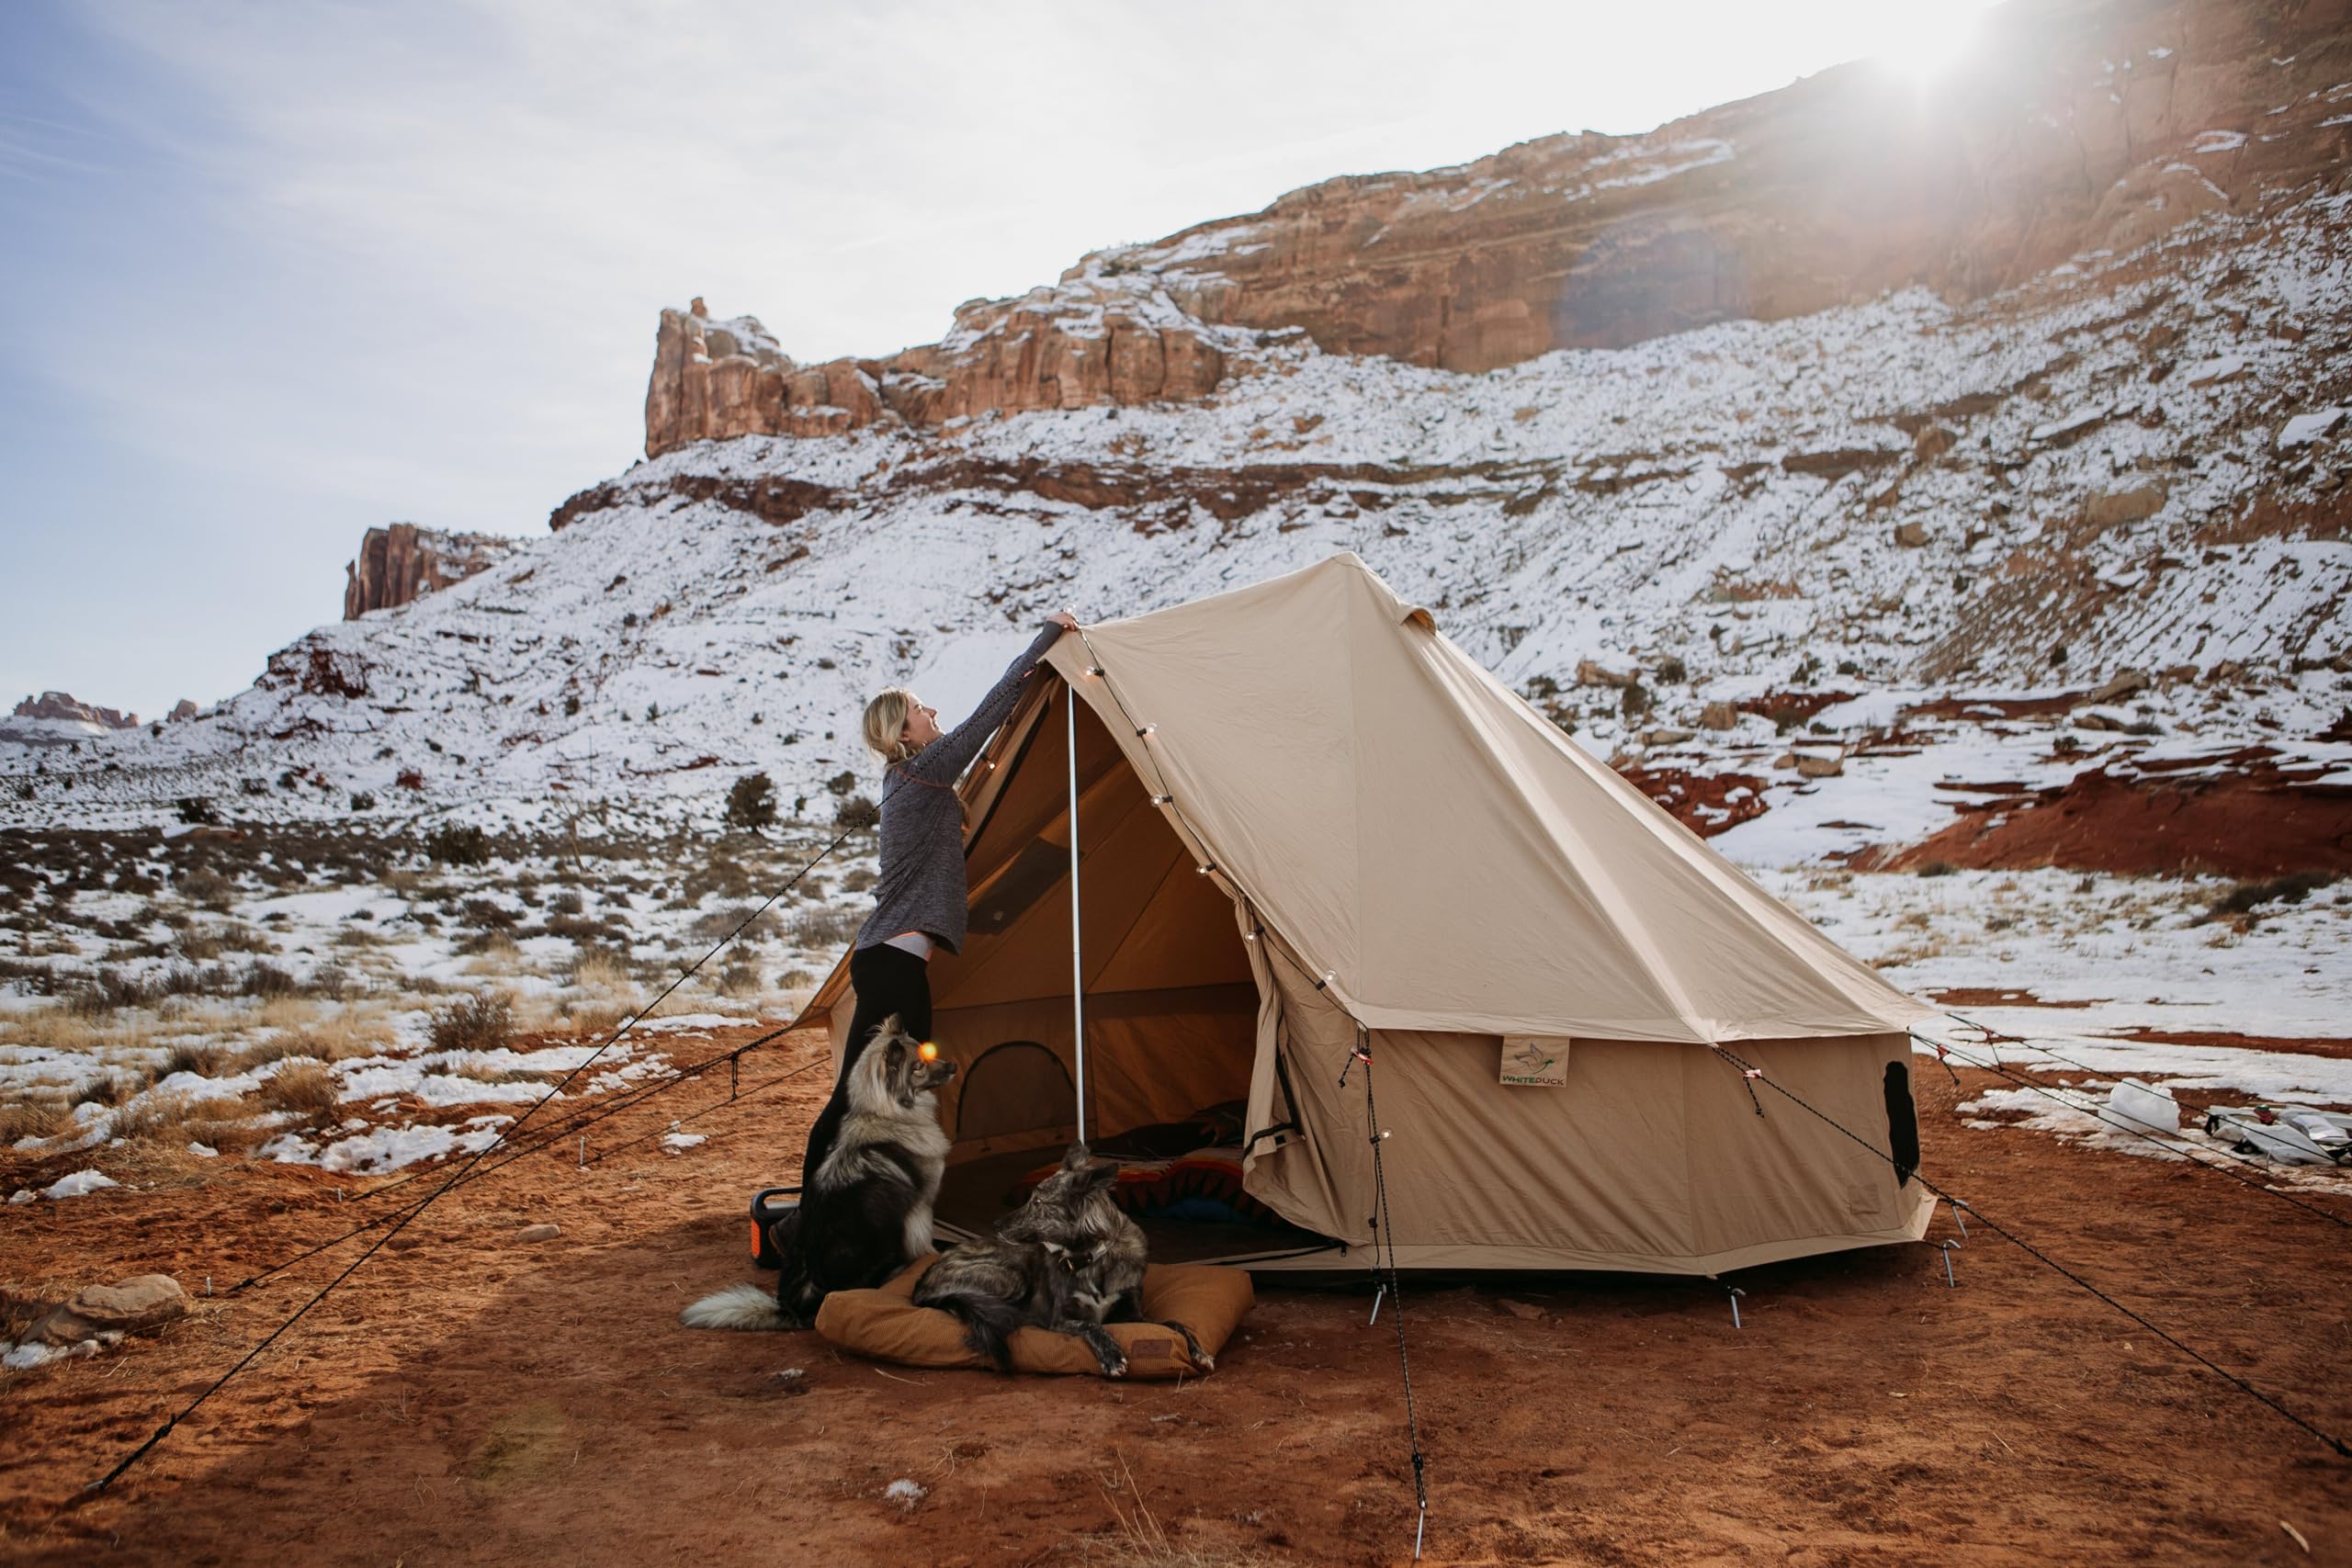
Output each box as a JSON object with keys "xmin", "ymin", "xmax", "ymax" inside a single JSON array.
[{"xmin": 644, "ymin": 0, "xmax": 2352, "ymax": 456}]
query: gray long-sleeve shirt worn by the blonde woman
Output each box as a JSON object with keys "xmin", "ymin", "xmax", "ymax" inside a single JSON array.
[{"xmin": 856, "ymin": 626, "xmax": 1061, "ymax": 952}]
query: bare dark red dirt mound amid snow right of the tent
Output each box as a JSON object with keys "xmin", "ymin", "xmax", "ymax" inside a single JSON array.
[{"xmin": 1884, "ymin": 764, "xmax": 2352, "ymax": 877}]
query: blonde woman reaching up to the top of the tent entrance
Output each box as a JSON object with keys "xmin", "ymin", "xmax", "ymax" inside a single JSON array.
[{"xmin": 799, "ymin": 614, "xmax": 1077, "ymax": 1182}]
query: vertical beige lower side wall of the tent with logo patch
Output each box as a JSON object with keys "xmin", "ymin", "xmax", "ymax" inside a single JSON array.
[{"xmin": 1247, "ymin": 954, "xmax": 1931, "ymax": 1274}]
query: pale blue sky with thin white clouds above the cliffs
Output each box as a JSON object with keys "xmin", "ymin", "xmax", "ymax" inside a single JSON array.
[{"xmin": 0, "ymin": 0, "xmax": 1969, "ymax": 715}]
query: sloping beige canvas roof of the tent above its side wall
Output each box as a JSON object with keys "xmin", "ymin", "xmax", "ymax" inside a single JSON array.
[{"xmin": 1049, "ymin": 555, "xmax": 1933, "ymax": 1042}]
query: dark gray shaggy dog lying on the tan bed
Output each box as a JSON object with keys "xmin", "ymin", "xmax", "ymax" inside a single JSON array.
[{"xmin": 915, "ymin": 1143, "xmax": 1216, "ymax": 1378}]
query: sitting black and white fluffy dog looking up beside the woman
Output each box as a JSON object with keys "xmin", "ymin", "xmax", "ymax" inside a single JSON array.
[{"xmin": 680, "ymin": 1016, "xmax": 955, "ymax": 1328}]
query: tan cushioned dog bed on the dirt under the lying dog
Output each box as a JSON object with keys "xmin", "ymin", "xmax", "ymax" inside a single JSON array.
[{"xmin": 816, "ymin": 1253, "xmax": 1259, "ymax": 1378}]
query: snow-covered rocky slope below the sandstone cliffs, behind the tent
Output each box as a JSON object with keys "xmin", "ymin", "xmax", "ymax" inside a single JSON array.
[{"xmin": 0, "ymin": 193, "xmax": 2352, "ymax": 841}]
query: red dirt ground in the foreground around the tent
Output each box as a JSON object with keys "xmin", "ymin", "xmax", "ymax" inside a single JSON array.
[{"xmin": 0, "ymin": 1037, "xmax": 2352, "ymax": 1568}]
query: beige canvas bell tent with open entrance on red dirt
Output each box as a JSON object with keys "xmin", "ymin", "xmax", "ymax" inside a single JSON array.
[{"xmin": 805, "ymin": 555, "xmax": 1931, "ymax": 1274}]
